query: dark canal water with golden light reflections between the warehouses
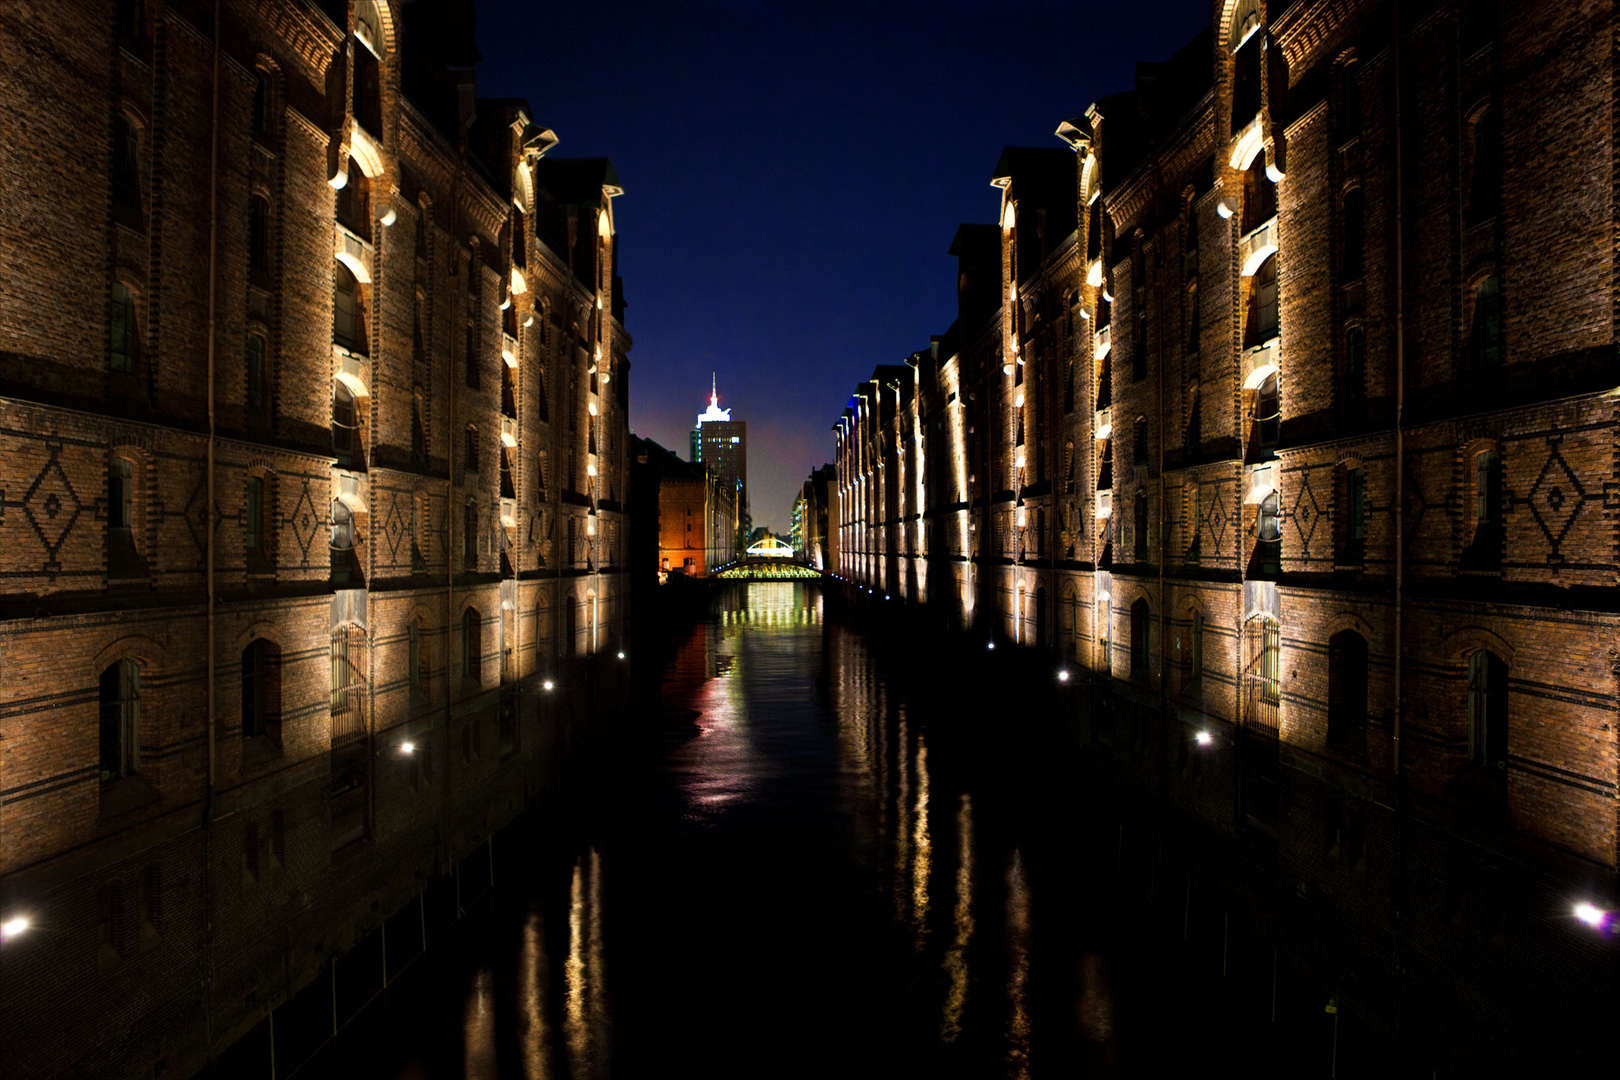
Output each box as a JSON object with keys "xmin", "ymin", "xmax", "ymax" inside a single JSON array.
[{"xmin": 294, "ymin": 583, "xmax": 1393, "ymax": 1080}]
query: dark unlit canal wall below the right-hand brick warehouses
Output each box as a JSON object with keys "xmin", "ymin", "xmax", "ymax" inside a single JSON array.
[{"xmin": 826, "ymin": 583, "xmax": 1620, "ymax": 1077}]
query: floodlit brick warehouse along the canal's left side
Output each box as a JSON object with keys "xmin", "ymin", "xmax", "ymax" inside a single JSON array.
[{"xmin": 0, "ymin": 0, "xmax": 630, "ymax": 1077}]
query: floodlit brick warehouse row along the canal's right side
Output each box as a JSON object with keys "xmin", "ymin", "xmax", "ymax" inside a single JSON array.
[{"xmin": 834, "ymin": 0, "xmax": 1620, "ymax": 1075}]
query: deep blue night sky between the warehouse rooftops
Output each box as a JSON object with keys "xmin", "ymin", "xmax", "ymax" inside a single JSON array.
[{"xmin": 476, "ymin": 0, "xmax": 1212, "ymax": 533}]
